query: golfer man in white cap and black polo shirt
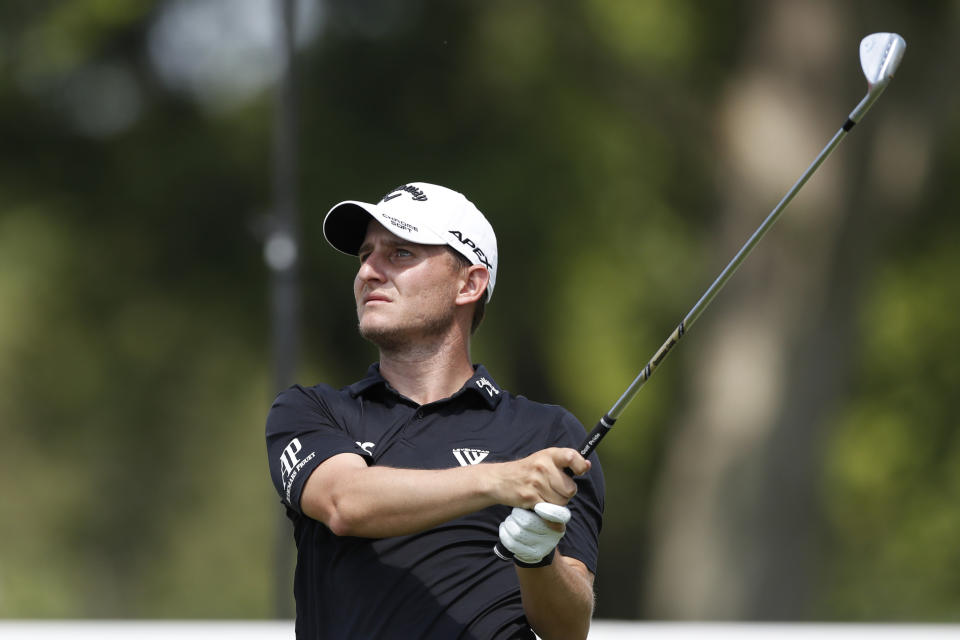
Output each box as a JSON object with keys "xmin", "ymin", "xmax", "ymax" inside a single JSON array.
[{"xmin": 266, "ymin": 183, "xmax": 603, "ymax": 640}]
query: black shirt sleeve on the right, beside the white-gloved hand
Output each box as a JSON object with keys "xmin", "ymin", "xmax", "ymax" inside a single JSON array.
[{"xmin": 557, "ymin": 411, "xmax": 605, "ymax": 574}]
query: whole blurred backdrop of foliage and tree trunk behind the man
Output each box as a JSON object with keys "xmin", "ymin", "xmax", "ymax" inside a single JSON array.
[{"xmin": 0, "ymin": 0, "xmax": 960, "ymax": 621}]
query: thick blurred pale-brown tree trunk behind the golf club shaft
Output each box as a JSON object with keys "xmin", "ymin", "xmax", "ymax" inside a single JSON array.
[{"xmin": 644, "ymin": 0, "xmax": 866, "ymax": 619}]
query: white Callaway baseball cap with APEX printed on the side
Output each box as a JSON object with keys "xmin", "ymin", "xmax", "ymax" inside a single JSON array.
[{"xmin": 323, "ymin": 182, "xmax": 497, "ymax": 302}]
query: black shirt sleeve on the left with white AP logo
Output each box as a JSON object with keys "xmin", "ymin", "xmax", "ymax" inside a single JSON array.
[{"xmin": 266, "ymin": 385, "xmax": 370, "ymax": 513}]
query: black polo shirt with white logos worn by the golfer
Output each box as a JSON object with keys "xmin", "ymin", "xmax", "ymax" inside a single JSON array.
[{"xmin": 266, "ymin": 364, "xmax": 604, "ymax": 640}]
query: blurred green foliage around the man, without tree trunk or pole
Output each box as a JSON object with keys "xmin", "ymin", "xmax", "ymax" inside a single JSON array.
[{"xmin": 0, "ymin": 0, "xmax": 960, "ymax": 620}]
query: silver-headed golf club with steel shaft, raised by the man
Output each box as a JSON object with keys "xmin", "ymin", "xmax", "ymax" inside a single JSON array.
[{"xmin": 494, "ymin": 33, "xmax": 907, "ymax": 560}]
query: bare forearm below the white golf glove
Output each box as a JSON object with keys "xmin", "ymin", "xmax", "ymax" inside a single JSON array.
[{"xmin": 517, "ymin": 551, "xmax": 593, "ymax": 640}]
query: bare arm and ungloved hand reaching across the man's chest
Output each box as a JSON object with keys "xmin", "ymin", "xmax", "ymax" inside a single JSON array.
[{"xmin": 300, "ymin": 448, "xmax": 590, "ymax": 538}]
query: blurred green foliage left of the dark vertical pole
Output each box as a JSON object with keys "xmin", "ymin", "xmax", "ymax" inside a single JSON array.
[{"xmin": 0, "ymin": 1, "xmax": 278, "ymax": 617}]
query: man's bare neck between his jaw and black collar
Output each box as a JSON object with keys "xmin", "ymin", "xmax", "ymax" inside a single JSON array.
[{"xmin": 380, "ymin": 336, "xmax": 473, "ymax": 405}]
